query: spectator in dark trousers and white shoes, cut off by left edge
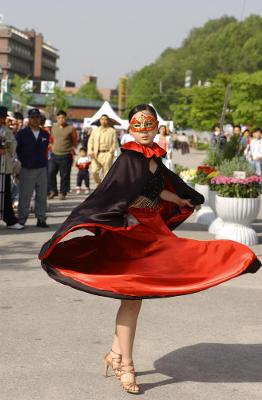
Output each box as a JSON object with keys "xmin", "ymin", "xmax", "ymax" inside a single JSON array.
[{"xmin": 0, "ymin": 106, "xmax": 24, "ymax": 230}]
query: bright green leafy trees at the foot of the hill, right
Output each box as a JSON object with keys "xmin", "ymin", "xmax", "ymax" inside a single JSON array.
[{"xmin": 170, "ymin": 71, "xmax": 262, "ymax": 130}]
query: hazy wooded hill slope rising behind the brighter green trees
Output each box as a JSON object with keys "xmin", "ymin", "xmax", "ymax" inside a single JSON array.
[{"xmin": 128, "ymin": 15, "xmax": 262, "ymax": 117}]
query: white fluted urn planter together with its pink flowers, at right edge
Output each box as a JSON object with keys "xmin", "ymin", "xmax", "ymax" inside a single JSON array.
[{"xmin": 211, "ymin": 175, "xmax": 262, "ymax": 246}]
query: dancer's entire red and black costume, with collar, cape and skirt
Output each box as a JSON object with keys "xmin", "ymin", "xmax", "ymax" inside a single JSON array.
[{"xmin": 39, "ymin": 142, "xmax": 261, "ymax": 299}]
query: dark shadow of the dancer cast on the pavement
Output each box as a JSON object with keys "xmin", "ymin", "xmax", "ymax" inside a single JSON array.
[{"xmin": 137, "ymin": 343, "xmax": 262, "ymax": 392}]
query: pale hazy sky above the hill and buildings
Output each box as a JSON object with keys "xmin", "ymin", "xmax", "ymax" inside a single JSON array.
[{"xmin": 0, "ymin": 0, "xmax": 262, "ymax": 88}]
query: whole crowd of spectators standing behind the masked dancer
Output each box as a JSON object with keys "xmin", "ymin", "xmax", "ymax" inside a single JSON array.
[{"xmin": 0, "ymin": 101, "xmax": 262, "ymax": 230}]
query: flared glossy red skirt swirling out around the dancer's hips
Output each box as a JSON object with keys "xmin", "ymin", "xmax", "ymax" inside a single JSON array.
[{"xmin": 43, "ymin": 208, "xmax": 260, "ymax": 298}]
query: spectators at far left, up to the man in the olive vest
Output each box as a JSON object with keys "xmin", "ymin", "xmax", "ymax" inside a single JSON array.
[{"xmin": 0, "ymin": 106, "xmax": 77, "ymax": 230}]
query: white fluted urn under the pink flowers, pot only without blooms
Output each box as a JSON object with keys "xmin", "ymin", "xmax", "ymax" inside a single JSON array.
[{"xmin": 216, "ymin": 195, "xmax": 260, "ymax": 246}]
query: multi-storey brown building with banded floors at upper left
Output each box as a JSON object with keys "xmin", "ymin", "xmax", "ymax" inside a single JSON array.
[{"xmin": 0, "ymin": 25, "xmax": 59, "ymax": 82}]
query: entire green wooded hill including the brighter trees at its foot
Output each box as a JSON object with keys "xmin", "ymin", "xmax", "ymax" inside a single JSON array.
[{"xmin": 127, "ymin": 15, "xmax": 262, "ymax": 126}]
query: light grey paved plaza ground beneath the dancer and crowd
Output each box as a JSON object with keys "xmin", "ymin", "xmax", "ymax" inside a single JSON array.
[{"xmin": 0, "ymin": 151, "xmax": 262, "ymax": 400}]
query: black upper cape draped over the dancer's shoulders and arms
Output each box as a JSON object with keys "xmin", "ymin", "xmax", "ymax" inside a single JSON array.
[{"xmin": 39, "ymin": 150, "xmax": 204, "ymax": 260}]
